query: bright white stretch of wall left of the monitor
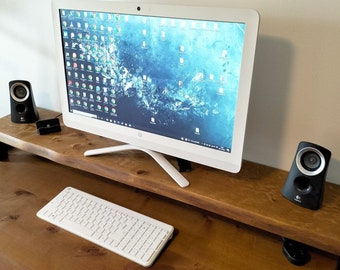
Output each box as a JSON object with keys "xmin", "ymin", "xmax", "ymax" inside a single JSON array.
[{"xmin": 0, "ymin": 0, "xmax": 59, "ymax": 116}]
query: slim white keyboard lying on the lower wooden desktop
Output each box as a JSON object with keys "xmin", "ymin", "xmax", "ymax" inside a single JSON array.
[{"xmin": 37, "ymin": 187, "xmax": 174, "ymax": 267}]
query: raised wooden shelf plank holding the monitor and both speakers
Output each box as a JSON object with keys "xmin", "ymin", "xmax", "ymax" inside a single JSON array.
[{"xmin": 0, "ymin": 109, "xmax": 340, "ymax": 256}]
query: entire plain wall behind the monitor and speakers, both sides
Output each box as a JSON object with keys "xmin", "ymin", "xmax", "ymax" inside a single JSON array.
[{"xmin": 0, "ymin": 0, "xmax": 340, "ymax": 184}]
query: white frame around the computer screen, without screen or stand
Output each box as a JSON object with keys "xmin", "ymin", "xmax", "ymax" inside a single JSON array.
[{"xmin": 52, "ymin": 0, "xmax": 259, "ymax": 173}]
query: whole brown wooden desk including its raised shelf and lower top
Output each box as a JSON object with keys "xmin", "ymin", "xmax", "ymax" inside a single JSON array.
[{"xmin": 0, "ymin": 110, "xmax": 340, "ymax": 269}]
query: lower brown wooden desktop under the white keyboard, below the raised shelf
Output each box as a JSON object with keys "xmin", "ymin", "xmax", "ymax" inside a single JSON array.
[{"xmin": 0, "ymin": 149, "xmax": 336, "ymax": 270}]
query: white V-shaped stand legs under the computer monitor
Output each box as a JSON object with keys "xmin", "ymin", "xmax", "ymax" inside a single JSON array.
[{"xmin": 84, "ymin": 144, "xmax": 190, "ymax": 187}]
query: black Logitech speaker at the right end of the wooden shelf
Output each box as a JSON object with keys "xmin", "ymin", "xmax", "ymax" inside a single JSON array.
[{"xmin": 282, "ymin": 142, "xmax": 331, "ymax": 210}]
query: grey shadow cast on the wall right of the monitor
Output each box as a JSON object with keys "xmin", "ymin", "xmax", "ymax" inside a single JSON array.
[{"xmin": 244, "ymin": 35, "xmax": 294, "ymax": 167}]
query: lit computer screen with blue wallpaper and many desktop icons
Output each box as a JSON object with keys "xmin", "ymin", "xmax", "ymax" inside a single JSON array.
[{"xmin": 60, "ymin": 10, "xmax": 245, "ymax": 152}]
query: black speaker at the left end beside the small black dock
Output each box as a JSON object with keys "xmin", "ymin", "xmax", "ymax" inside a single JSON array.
[{"xmin": 9, "ymin": 80, "xmax": 39, "ymax": 123}]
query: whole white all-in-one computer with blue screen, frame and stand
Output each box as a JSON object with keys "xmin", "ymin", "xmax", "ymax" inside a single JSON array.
[{"xmin": 53, "ymin": 0, "xmax": 259, "ymax": 186}]
